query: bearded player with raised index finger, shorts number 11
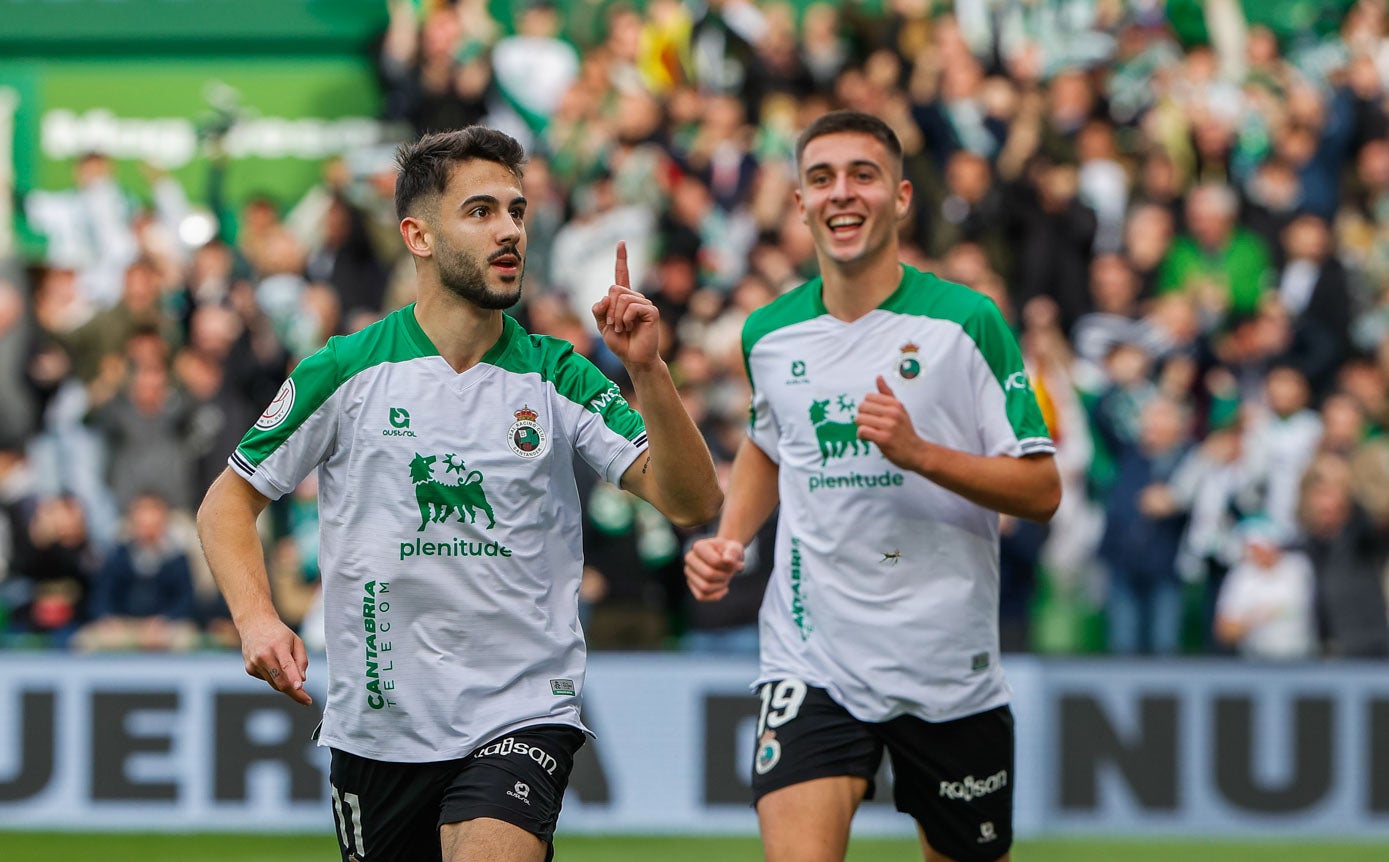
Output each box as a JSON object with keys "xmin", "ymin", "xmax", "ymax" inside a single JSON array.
[{"xmin": 199, "ymin": 126, "xmax": 722, "ymax": 862}]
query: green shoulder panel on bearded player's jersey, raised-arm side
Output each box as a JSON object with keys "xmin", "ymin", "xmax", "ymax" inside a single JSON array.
[{"xmin": 483, "ymin": 316, "xmax": 646, "ymax": 440}]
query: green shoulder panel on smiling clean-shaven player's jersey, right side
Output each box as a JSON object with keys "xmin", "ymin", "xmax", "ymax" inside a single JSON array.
[{"xmin": 883, "ymin": 267, "xmax": 1050, "ymax": 440}]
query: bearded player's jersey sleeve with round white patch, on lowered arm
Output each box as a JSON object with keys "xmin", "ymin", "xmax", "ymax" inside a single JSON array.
[{"xmin": 226, "ymin": 341, "xmax": 339, "ymax": 500}]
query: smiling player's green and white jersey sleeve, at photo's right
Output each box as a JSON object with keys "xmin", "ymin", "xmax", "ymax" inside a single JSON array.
[{"xmin": 968, "ymin": 295, "xmax": 1056, "ymax": 458}]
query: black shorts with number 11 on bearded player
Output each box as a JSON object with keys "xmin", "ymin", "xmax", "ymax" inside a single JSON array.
[{"xmin": 329, "ymin": 725, "xmax": 585, "ymax": 862}]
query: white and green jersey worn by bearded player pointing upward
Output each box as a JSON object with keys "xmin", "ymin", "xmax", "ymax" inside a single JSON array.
[{"xmin": 229, "ymin": 305, "xmax": 646, "ymax": 762}]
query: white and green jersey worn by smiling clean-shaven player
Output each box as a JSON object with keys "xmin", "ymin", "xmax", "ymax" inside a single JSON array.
[{"xmin": 743, "ymin": 267, "xmax": 1054, "ymax": 722}]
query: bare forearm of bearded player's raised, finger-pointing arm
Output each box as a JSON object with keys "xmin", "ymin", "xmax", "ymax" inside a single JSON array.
[{"xmin": 628, "ymin": 361, "xmax": 724, "ymax": 526}]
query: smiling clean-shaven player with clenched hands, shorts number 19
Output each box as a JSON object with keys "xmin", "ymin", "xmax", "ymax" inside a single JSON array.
[{"xmin": 686, "ymin": 111, "xmax": 1061, "ymax": 862}]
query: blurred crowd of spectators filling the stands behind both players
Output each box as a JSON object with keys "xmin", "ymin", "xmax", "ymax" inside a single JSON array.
[{"xmin": 0, "ymin": 0, "xmax": 1389, "ymax": 659}]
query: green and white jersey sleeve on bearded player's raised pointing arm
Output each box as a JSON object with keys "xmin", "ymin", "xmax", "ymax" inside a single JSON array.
[{"xmin": 556, "ymin": 353, "xmax": 646, "ymax": 484}]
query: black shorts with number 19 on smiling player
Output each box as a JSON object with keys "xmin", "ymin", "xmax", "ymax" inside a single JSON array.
[{"xmin": 753, "ymin": 679, "xmax": 1013, "ymax": 862}]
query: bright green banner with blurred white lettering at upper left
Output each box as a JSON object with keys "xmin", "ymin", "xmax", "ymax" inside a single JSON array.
[{"xmin": 0, "ymin": 57, "xmax": 383, "ymax": 223}]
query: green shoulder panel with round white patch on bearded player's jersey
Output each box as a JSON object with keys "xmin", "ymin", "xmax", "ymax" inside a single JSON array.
[{"xmin": 236, "ymin": 305, "xmax": 438, "ymax": 466}]
